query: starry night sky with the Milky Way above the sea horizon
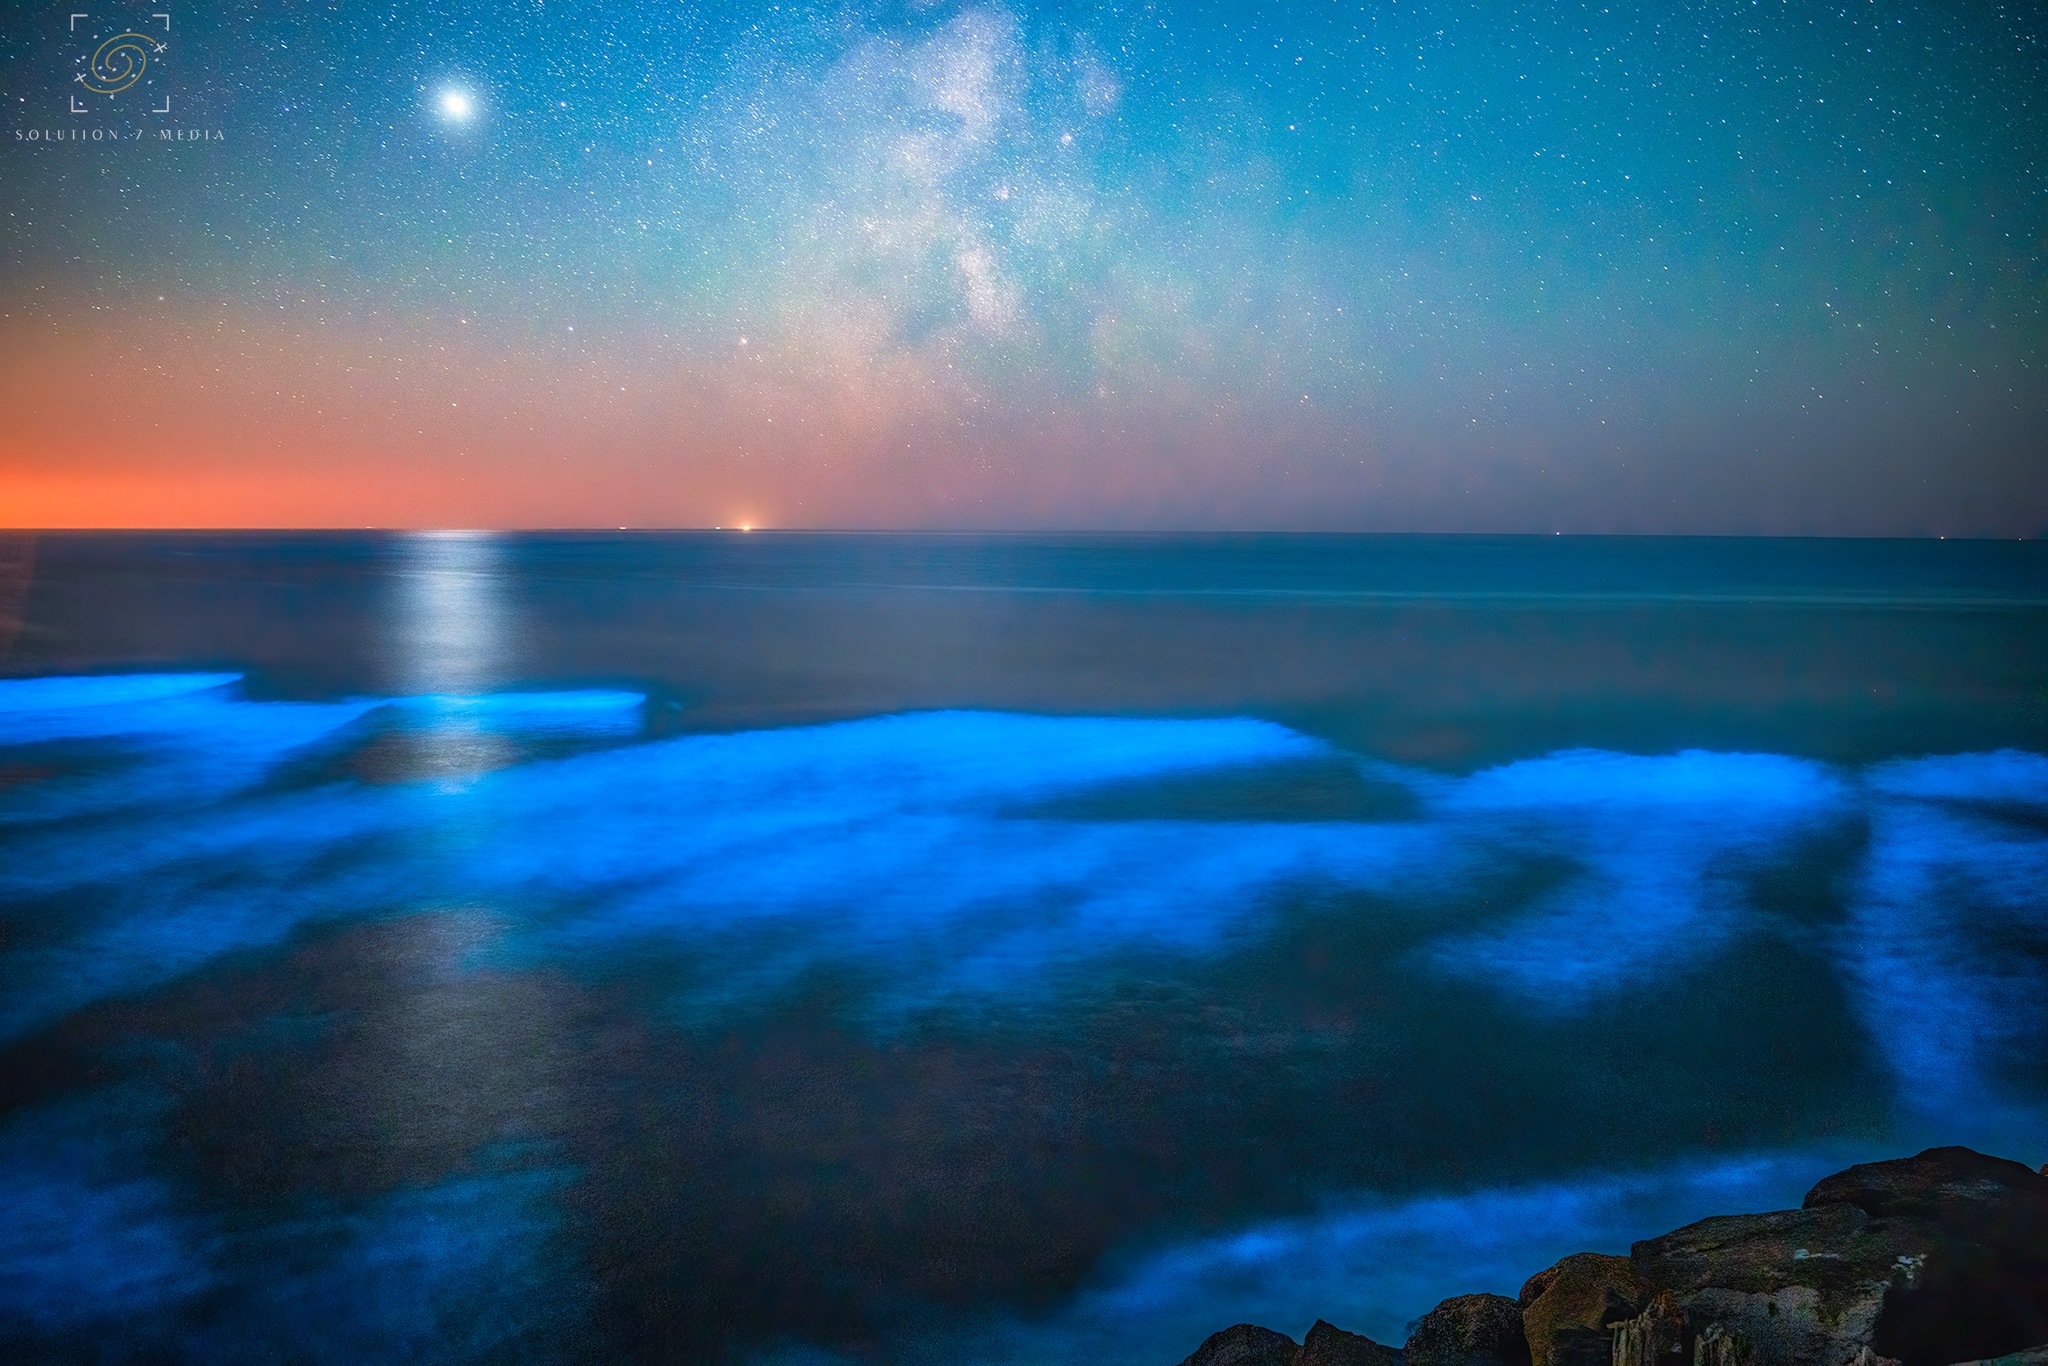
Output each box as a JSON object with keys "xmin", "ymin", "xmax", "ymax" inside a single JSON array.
[{"xmin": 0, "ymin": 0, "xmax": 2048, "ymax": 537}]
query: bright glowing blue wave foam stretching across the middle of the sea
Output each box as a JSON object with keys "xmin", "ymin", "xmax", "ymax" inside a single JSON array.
[{"xmin": 0, "ymin": 676, "xmax": 2048, "ymax": 1138}]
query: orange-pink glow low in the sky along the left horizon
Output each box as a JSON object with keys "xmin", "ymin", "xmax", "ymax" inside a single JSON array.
[{"xmin": 0, "ymin": 301, "xmax": 1359, "ymax": 532}]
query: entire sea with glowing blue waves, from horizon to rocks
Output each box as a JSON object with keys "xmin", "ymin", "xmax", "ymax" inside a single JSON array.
[{"xmin": 0, "ymin": 537, "xmax": 2048, "ymax": 1366}]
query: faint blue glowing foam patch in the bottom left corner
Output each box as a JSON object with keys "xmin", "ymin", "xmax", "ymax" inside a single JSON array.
[{"xmin": 0, "ymin": 1094, "xmax": 573, "ymax": 1360}]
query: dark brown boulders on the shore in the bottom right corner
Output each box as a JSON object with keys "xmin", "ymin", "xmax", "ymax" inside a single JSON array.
[{"xmin": 1182, "ymin": 1147, "xmax": 2048, "ymax": 1366}]
